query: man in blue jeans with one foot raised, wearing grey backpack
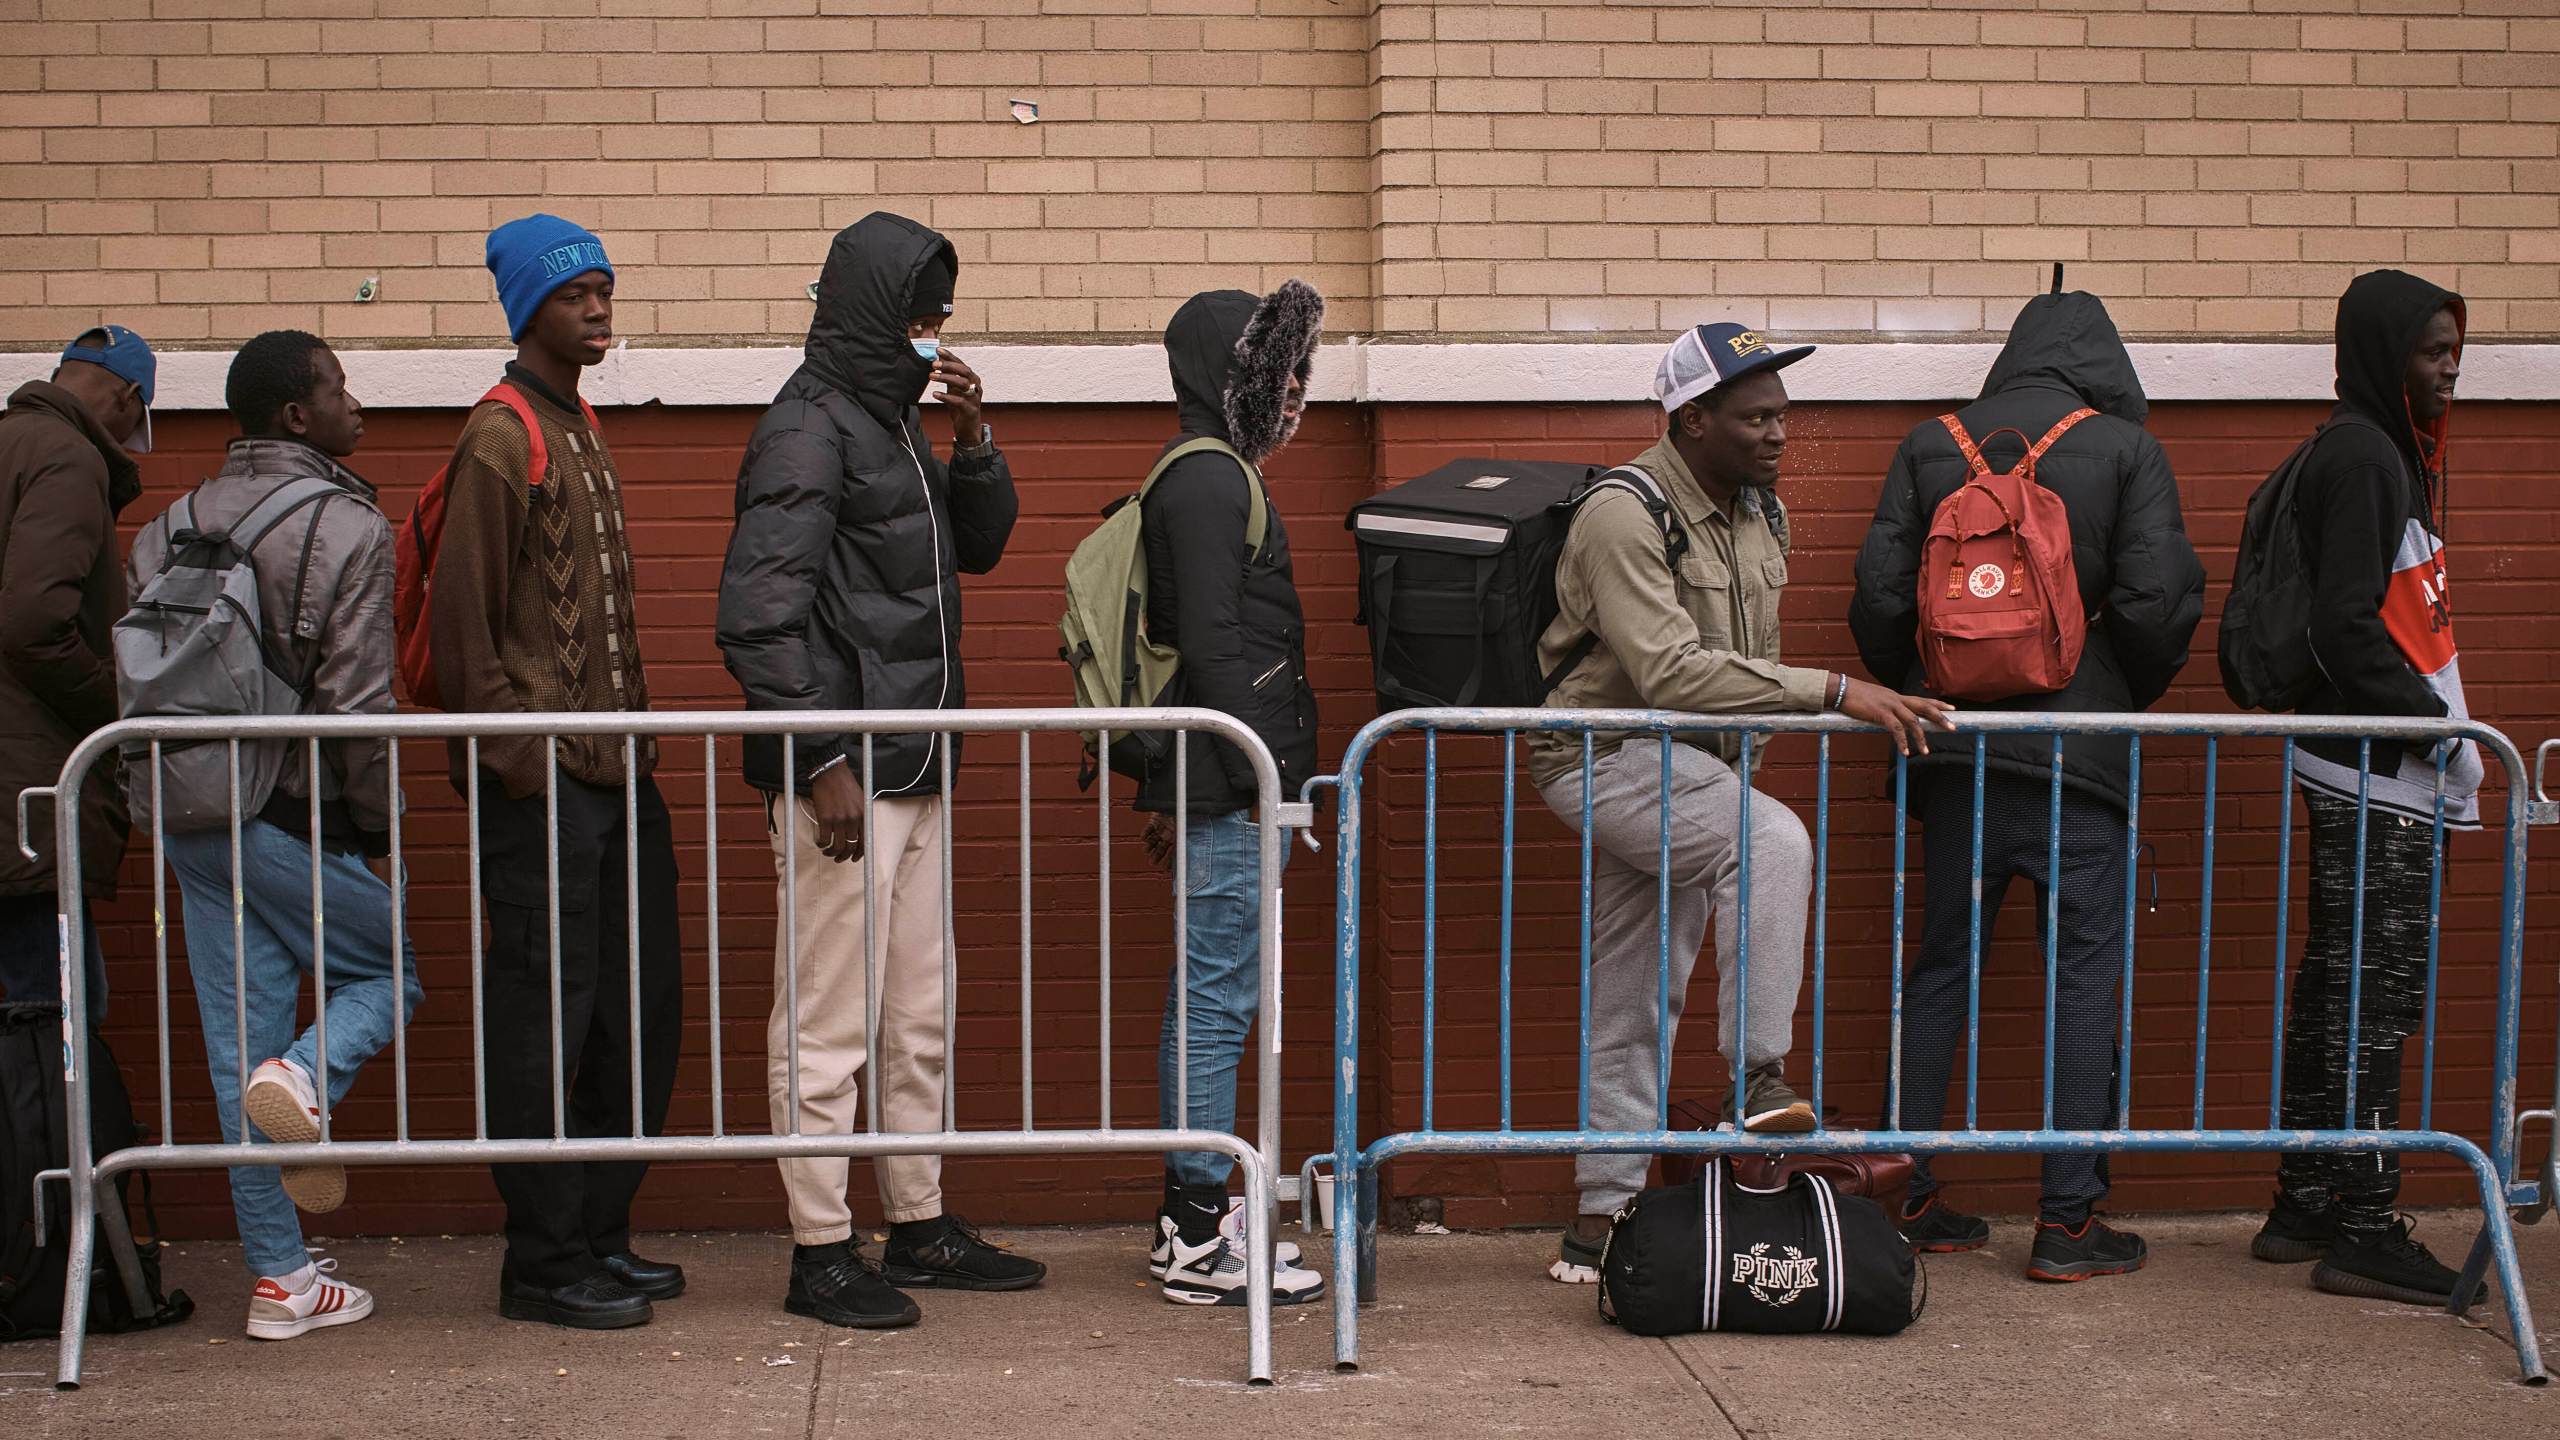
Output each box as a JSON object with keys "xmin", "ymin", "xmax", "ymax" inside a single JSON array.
[{"xmin": 128, "ymin": 331, "xmax": 420, "ymax": 1340}]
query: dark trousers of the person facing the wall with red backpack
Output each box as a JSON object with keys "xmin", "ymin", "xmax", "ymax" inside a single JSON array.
[{"xmin": 1887, "ymin": 771, "xmax": 2125, "ymax": 1225}]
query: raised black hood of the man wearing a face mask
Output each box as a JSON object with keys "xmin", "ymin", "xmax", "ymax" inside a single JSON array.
[{"xmin": 804, "ymin": 210, "xmax": 960, "ymax": 428}]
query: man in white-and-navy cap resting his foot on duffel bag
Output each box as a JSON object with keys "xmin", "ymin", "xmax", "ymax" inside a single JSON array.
[{"xmin": 1528, "ymin": 325, "xmax": 1946, "ymax": 1284}]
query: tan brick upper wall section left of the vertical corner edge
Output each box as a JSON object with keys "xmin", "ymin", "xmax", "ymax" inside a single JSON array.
[{"xmin": 0, "ymin": 0, "xmax": 1372, "ymax": 343}]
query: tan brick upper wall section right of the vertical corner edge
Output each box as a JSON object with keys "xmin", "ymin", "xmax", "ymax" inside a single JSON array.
[{"xmin": 1377, "ymin": 0, "xmax": 2560, "ymax": 336}]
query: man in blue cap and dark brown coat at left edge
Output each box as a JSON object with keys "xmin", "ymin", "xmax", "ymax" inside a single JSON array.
[{"xmin": 0, "ymin": 325, "xmax": 159, "ymax": 1020}]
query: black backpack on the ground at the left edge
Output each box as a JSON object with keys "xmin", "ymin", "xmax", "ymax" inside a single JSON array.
[{"xmin": 0, "ymin": 1004, "xmax": 195, "ymax": 1340}]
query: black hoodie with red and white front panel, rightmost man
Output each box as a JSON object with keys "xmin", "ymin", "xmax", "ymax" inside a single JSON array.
[{"xmin": 2294, "ymin": 269, "xmax": 2478, "ymax": 820}]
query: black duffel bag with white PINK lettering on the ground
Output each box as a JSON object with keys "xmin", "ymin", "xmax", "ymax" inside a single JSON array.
[{"xmin": 1600, "ymin": 1156, "xmax": 1928, "ymax": 1335}]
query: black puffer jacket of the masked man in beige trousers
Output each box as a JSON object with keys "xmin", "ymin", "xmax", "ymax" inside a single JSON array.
[{"xmin": 719, "ymin": 213, "xmax": 1016, "ymax": 794}]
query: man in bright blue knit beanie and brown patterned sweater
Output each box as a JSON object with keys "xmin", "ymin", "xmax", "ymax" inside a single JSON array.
[{"xmin": 428, "ymin": 215, "xmax": 684, "ymax": 1330}]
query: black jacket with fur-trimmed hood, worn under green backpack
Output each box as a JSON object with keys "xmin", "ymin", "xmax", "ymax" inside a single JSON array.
[{"xmin": 1137, "ymin": 284, "xmax": 1321, "ymax": 815}]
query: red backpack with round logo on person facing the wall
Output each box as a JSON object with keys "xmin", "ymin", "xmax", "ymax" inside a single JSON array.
[{"xmin": 1920, "ymin": 410, "xmax": 2097, "ymax": 700}]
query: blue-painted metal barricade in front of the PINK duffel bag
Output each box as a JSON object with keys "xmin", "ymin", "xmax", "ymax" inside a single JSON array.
[{"xmin": 1324, "ymin": 710, "xmax": 2542, "ymax": 1384}]
